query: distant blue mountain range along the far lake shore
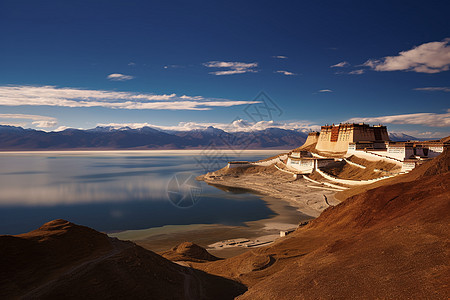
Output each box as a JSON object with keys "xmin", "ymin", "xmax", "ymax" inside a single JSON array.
[{"xmin": 0, "ymin": 125, "xmax": 424, "ymax": 150}]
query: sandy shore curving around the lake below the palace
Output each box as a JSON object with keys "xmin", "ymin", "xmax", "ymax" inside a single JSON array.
[{"xmin": 110, "ymin": 172, "xmax": 339, "ymax": 257}]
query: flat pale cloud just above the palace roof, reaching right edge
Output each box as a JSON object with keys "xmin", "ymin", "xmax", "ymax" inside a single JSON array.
[{"xmin": 346, "ymin": 110, "xmax": 450, "ymax": 127}]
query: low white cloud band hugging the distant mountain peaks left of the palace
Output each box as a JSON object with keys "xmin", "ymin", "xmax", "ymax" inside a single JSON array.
[{"xmin": 97, "ymin": 119, "xmax": 320, "ymax": 132}]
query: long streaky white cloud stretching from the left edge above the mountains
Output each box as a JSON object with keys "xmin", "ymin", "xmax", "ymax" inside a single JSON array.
[{"xmin": 0, "ymin": 86, "xmax": 259, "ymax": 110}]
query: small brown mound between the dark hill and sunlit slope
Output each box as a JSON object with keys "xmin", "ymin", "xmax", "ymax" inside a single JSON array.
[{"xmin": 161, "ymin": 242, "xmax": 220, "ymax": 262}]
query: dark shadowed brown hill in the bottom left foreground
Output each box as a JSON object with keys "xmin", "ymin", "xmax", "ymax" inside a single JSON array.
[{"xmin": 0, "ymin": 220, "xmax": 245, "ymax": 299}]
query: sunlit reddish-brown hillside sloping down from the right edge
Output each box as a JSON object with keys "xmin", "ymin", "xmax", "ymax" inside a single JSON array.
[{"xmin": 194, "ymin": 152, "xmax": 450, "ymax": 299}]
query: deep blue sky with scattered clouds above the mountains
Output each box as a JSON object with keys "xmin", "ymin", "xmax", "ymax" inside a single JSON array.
[{"xmin": 0, "ymin": 0, "xmax": 450, "ymax": 137}]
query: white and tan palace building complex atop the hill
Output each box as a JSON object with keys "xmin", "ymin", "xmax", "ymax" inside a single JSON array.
[{"xmin": 286, "ymin": 123, "xmax": 450, "ymax": 174}]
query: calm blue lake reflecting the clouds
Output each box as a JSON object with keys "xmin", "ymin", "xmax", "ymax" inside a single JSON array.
[{"xmin": 0, "ymin": 150, "xmax": 282, "ymax": 234}]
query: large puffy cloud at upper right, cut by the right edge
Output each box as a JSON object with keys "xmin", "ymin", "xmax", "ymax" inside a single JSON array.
[{"xmin": 364, "ymin": 38, "xmax": 450, "ymax": 73}]
